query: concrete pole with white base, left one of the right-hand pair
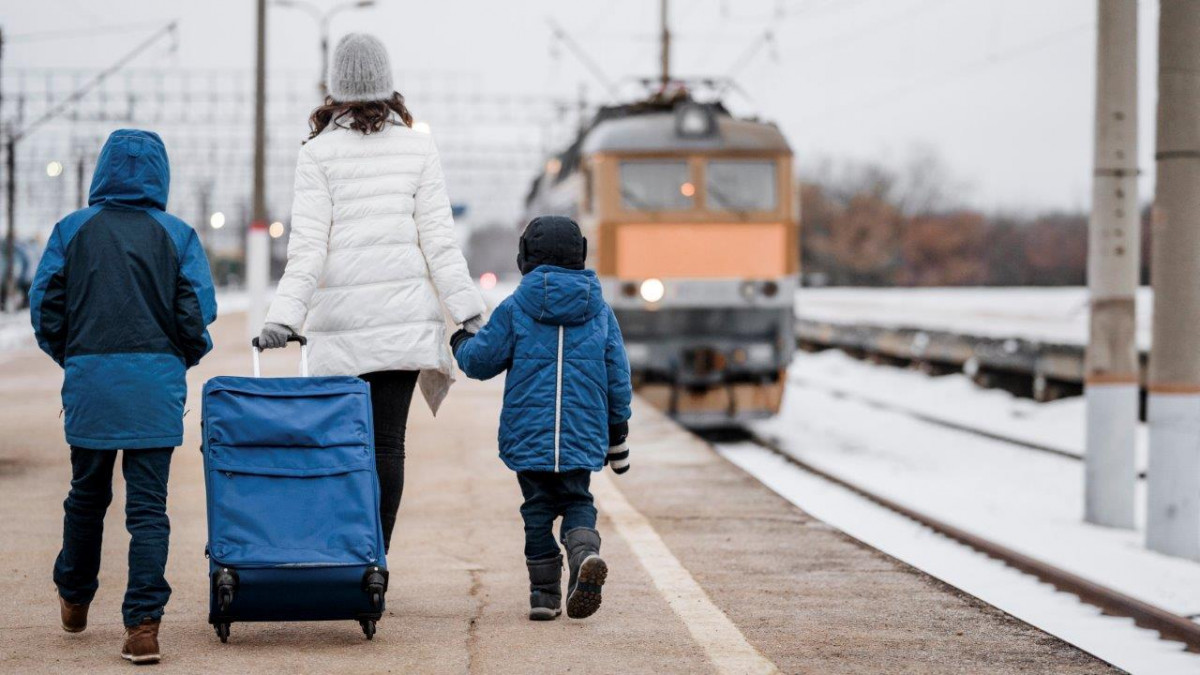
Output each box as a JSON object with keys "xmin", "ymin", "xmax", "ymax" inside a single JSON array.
[{"xmin": 1084, "ymin": 0, "xmax": 1141, "ymax": 530}]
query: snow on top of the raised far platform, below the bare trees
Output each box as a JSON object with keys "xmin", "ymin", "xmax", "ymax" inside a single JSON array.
[{"xmin": 796, "ymin": 287, "xmax": 1153, "ymax": 350}]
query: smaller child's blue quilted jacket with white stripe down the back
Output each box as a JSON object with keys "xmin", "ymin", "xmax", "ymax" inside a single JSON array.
[{"xmin": 455, "ymin": 265, "xmax": 632, "ymax": 471}]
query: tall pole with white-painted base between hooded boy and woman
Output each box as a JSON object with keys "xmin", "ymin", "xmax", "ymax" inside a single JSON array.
[{"xmin": 246, "ymin": 0, "xmax": 270, "ymax": 335}]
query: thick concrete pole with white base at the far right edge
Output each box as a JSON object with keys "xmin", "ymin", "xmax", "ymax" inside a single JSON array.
[{"xmin": 1146, "ymin": 0, "xmax": 1200, "ymax": 560}]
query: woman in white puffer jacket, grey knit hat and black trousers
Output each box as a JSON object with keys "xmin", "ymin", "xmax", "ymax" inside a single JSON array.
[{"xmin": 259, "ymin": 34, "xmax": 484, "ymax": 545}]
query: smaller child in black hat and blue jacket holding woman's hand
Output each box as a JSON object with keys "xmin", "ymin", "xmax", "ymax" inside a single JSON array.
[{"xmin": 451, "ymin": 216, "xmax": 631, "ymax": 621}]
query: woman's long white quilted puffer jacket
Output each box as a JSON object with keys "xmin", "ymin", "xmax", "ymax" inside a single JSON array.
[{"xmin": 266, "ymin": 124, "xmax": 485, "ymax": 412}]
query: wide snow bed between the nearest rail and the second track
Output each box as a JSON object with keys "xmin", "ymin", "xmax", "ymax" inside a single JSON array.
[{"xmin": 755, "ymin": 354, "xmax": 1200, "ymax": 616}]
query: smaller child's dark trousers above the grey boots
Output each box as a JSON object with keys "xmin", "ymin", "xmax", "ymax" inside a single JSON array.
[{"xmin": 517, "ymin": 468, "xmax": 596, "ymax": 560}]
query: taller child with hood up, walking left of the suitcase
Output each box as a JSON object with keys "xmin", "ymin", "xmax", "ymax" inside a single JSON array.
[{"xmin": 29, "ymin": 129, "xmax": 217, "ymax": 663}]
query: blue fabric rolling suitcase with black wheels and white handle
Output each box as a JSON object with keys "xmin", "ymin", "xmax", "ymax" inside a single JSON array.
[{"xmin": 202, "ymin": 336, "xmax": 388, "ymax": 643}]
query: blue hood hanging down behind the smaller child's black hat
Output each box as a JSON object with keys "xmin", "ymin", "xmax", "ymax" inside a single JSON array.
[{"xmin": 512, "ymin": 265, "xmax": 605, "ymax": 325}]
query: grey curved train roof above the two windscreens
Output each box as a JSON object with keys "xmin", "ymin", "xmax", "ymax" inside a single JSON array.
[{"xmin": 581, "ymin": 109, "xmax": 791, "ymax": 154}]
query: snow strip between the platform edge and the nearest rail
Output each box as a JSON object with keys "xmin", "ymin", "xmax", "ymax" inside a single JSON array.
[{"xmin": 718, "ymin": 438, "xmax": 1200, "ymax": 675}]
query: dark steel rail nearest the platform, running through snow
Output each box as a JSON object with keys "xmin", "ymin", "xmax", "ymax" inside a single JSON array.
[{"xmin": 745, "ymin": 430, "xmax": 1200, "ymax": 652}]
